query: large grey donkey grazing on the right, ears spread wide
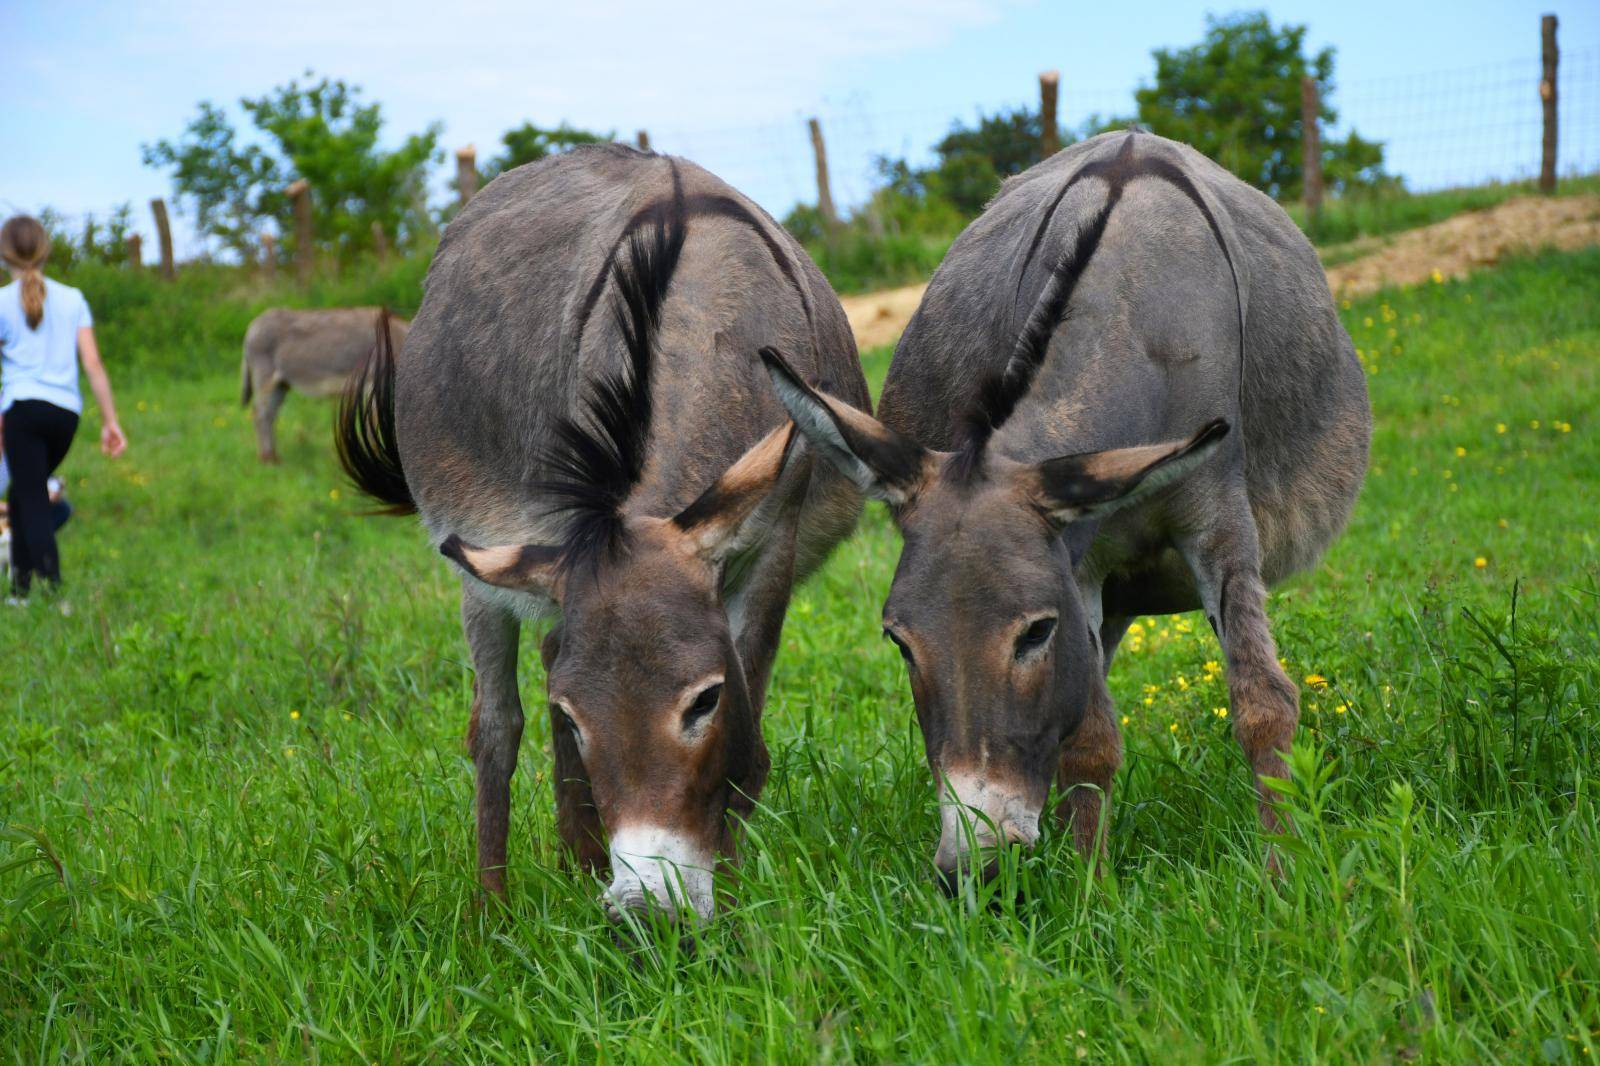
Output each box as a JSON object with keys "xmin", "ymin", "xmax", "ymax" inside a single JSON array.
[{"xmin": 763, "ymin": 133, "xmax": 1371, "ymax": 882}]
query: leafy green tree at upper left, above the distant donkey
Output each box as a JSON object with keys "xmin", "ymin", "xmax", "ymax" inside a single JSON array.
[{"xmin": 144, "ymin": 72, "xmax": 440, "ymax": 256}]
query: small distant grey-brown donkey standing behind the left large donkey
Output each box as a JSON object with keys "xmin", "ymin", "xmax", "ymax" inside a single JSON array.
[{"xmin": 240, "ymin": 307, "xmax": 410, "ymax": 463}]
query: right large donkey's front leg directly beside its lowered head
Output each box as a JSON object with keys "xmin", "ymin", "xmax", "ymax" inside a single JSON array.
[{"xmin": 1056, "ymin": 576, "xmax": 1131, "ymax": 858}]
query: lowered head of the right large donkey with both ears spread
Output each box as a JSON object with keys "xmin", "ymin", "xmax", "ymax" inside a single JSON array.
[{"xmin": 762, "ymin": 349, "xmax": 1227, "ymax": 880}]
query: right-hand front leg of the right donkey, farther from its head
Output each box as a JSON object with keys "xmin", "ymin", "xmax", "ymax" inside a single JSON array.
[{"xmin": 1179, "ymin": 493, "xmax": 1299, "ymax": 845}]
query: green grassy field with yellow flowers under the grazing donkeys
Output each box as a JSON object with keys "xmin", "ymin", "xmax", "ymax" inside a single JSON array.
[{"xmin": 0, "ymin": 251, "xmax": 1600, "ymax": 1063}]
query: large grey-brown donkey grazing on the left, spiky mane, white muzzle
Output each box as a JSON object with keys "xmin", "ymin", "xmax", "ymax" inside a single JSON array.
[{"xmin": 339, "ymin": 146, "xmax": 869, "ymax": 917}]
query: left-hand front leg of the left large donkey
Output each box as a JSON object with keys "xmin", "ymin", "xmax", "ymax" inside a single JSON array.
[{"xmin": 461, "ymin": 587, "xmax": 522, "ymax": 898}]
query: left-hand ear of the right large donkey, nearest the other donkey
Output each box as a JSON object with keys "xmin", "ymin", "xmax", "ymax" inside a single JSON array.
[{"xmin": 762, "ymin": 347, "xmax": 928, "ymax": 507}]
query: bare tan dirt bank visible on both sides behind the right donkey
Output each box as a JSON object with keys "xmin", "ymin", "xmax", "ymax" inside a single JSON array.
[{"xmin": 843, "ymin": 195, "xmax": 1600, "ymax": 351}]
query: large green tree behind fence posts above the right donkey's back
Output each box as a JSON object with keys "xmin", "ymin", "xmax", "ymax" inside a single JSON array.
[{"xmin": 1106, "ymin": 11, "xmax": 1392, "ymax": 198}]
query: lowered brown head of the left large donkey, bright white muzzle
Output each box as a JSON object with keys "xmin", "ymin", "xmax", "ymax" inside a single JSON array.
[{"xmin": 440, "ymin": 424, "xmax": 794, "ymax": 917}]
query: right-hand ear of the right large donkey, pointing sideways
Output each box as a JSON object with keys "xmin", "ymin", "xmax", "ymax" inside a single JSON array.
[{"xmin": 1027, "ymin": 418, "xmax": 1229, "ymax": 525}]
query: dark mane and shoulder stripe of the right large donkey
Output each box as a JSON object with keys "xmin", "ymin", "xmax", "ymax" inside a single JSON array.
[{"xmin": 952, "ymin": 130, "xmax": 1245, "ymax": 480}]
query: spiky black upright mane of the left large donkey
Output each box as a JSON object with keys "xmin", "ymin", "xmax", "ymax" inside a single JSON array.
[{"xmin": 534, "ymin": 165, "xmax": 688, "ymax": 573}]
